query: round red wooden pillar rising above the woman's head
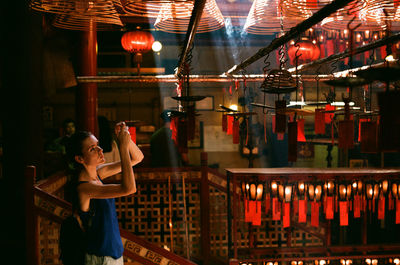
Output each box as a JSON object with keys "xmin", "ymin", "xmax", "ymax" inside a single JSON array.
[{"xmin": 75, "ymin": 22, "xmax": 98, "ymax": 136}]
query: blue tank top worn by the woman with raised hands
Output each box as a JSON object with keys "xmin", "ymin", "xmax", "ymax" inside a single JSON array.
[{"xmin": 80, "ymin": 180, "xmax": 124, "ymax": 259}]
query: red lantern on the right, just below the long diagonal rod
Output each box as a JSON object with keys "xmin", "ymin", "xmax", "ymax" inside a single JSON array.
[{"xmin": 288, "ymin": 40, "xmax": 320, "ymax": 65}]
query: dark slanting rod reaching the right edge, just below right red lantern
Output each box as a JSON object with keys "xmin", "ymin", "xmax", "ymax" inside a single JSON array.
[{"xmin": 288, "ymin": 33, "xmax": 400, "ymax": 72}]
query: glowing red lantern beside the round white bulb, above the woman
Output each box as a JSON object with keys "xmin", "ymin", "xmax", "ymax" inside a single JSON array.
[{"xmin": 121, "ymin": 31, "xmax": 154, "ymax": 53}]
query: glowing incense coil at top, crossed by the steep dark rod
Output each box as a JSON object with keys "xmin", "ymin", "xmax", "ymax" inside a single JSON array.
[{"xmin": 154, "ymin": 0, "xmax": 225, "ymax": 34}]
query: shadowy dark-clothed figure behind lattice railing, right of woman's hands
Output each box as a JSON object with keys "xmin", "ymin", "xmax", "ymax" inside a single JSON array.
[{"xmin": 150, "ymin": 110, "xmax": 188, "ymax": 167}]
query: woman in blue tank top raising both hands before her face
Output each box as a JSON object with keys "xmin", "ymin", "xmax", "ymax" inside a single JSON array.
[{"xmin": 66, "ymin": 122, "xmax": 143, "ymax": 265}]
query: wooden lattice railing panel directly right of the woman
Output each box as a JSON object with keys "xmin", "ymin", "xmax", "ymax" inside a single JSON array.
[{"xmin": 116, "ymin": 172, "xmax": 200, "ymax": 256}]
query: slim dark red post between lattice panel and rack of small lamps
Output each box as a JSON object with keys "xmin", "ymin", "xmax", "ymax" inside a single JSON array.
[{"xmin": 200, "ymin": 152, "xmax": 211, "ymax": 264}]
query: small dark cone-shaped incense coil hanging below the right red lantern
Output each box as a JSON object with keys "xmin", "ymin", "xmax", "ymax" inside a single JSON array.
[{"xmin": 260, "ymin": 69, "xmax": 296, "ymax": 94}]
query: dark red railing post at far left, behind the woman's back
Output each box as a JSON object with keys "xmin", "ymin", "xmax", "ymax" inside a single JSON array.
[{"xmin": 24, "ymin": 166, "xmax": 40, "ymax": 265}]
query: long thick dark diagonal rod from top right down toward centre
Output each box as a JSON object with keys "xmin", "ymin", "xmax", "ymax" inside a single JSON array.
[{"xmin": 224, "ymin": 0, "xmax": 352, "ymax": 75}]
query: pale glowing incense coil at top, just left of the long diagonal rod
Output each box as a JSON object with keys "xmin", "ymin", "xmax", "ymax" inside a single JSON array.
[{"xmin": 244, "ymin": 0, "xmax": 300, "ymax": 35}]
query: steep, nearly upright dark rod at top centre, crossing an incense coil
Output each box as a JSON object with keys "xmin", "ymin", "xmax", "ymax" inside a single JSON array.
[{"xmin": 175, "ymin": 0, "xmax": 206, "ymax": 77}]
